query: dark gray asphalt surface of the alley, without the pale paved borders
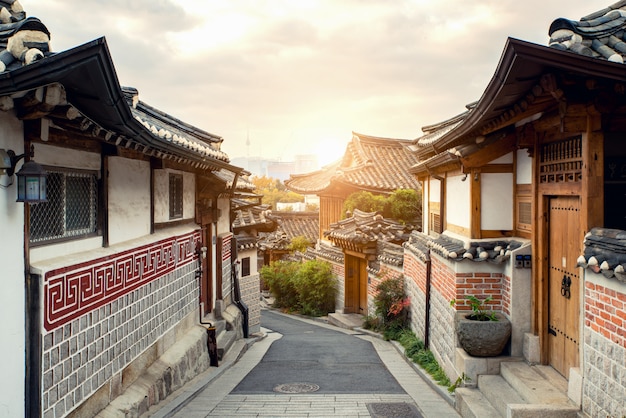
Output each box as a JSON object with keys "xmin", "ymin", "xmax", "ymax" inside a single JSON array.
[{"xmin": 233, "ymin": 310, "xmax": 405, "ymax": 394}]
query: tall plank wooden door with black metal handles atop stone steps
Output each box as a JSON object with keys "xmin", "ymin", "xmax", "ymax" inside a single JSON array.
[{"xmin": 548, "ymin": 196, "xmax": 582, "ymax": 378}]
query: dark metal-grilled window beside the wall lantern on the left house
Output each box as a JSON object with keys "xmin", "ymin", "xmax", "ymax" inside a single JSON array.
[{"xmin": 30, "ymin": 167, "xmax": 98, "ymax": 243}]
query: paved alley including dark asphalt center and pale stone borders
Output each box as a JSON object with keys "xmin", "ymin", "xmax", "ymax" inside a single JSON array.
[{"xmin": 165, "ymin": 310, "xmax": 458, "ymax": 418}]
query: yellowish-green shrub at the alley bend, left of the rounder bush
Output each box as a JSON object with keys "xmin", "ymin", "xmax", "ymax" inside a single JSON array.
[{"xmin": 260, "ymin": 261, "xmax": 300, "ymax": 309}]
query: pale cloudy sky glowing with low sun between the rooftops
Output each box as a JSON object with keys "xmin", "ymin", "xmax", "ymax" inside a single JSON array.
[{"xmin": 25, "ymin": 0, "xmax": 596, "ymax": 164}]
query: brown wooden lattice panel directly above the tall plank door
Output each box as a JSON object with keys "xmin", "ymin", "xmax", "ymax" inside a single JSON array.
[{"xmin": 539, "ymin": 137, "xmax": 583, "ymax": 183}]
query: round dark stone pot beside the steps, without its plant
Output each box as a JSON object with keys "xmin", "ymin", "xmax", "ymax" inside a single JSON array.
[{"xmin": 456, "ymin": 312, "xmax": 511, "ymax": 357}]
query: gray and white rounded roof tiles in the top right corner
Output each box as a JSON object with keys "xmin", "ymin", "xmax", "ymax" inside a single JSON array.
[{"xmin": 548, "ymin": 0, "xmax": 626, "ymax": 64}]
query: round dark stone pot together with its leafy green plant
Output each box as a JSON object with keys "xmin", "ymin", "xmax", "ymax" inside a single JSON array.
[{"xmin": 450, "ymin": 295, "xmax": 511, "ymax": 357}]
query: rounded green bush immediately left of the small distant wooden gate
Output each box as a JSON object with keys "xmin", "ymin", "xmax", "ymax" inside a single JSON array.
[{"xmin": 295, "ymin": 260, "xmax": 337, "ymax": 316}]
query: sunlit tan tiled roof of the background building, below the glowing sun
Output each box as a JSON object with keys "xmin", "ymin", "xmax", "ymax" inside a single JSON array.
[{"xmin": 285, "ymin": 133, "xmax": 420, "ymax": 194}]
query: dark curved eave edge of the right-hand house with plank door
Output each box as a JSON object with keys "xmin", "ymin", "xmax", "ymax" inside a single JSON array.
[{"xmin": 431, "ymin": 38, "xmax": 626, "ymax": 153}]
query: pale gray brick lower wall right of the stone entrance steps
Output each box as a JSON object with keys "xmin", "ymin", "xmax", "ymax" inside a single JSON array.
[{"xmin": 583, "ymin": 327, "xmax": 626, "ymax": 417}]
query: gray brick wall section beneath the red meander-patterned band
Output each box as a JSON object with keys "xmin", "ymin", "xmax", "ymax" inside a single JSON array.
[{"xmin": 42, "ymin": 263, "xmax": 198, "ymax": 418}]
